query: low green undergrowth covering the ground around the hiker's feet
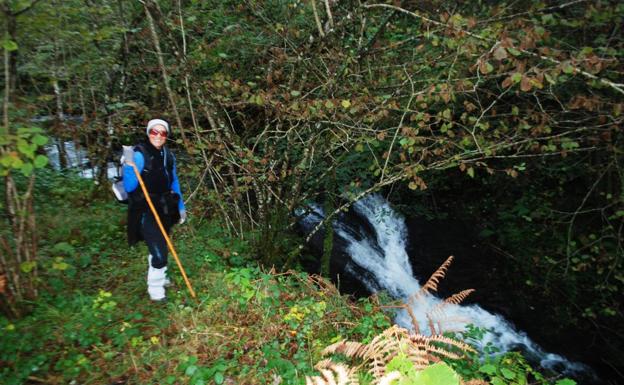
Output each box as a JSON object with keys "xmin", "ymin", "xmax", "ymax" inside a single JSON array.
[{"xmin": 0, "ymin": 174, "xmax": 576, "ymax": 385}]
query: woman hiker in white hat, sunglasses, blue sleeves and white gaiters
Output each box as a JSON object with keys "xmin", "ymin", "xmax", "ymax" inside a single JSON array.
[{"xmin": 123, "ymin": 119, "xmax": 186, "ymax": 302}]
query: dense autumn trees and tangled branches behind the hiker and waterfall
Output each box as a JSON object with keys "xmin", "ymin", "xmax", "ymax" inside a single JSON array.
[{"xmin": 0, "ymin": 0, "xmax": 624, "ymax": 381}]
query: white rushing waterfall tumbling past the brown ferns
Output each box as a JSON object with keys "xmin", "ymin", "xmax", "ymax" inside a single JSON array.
[{"xmin": 299, "ymin": 194, "xmax": 591, "ymax": 375}]
